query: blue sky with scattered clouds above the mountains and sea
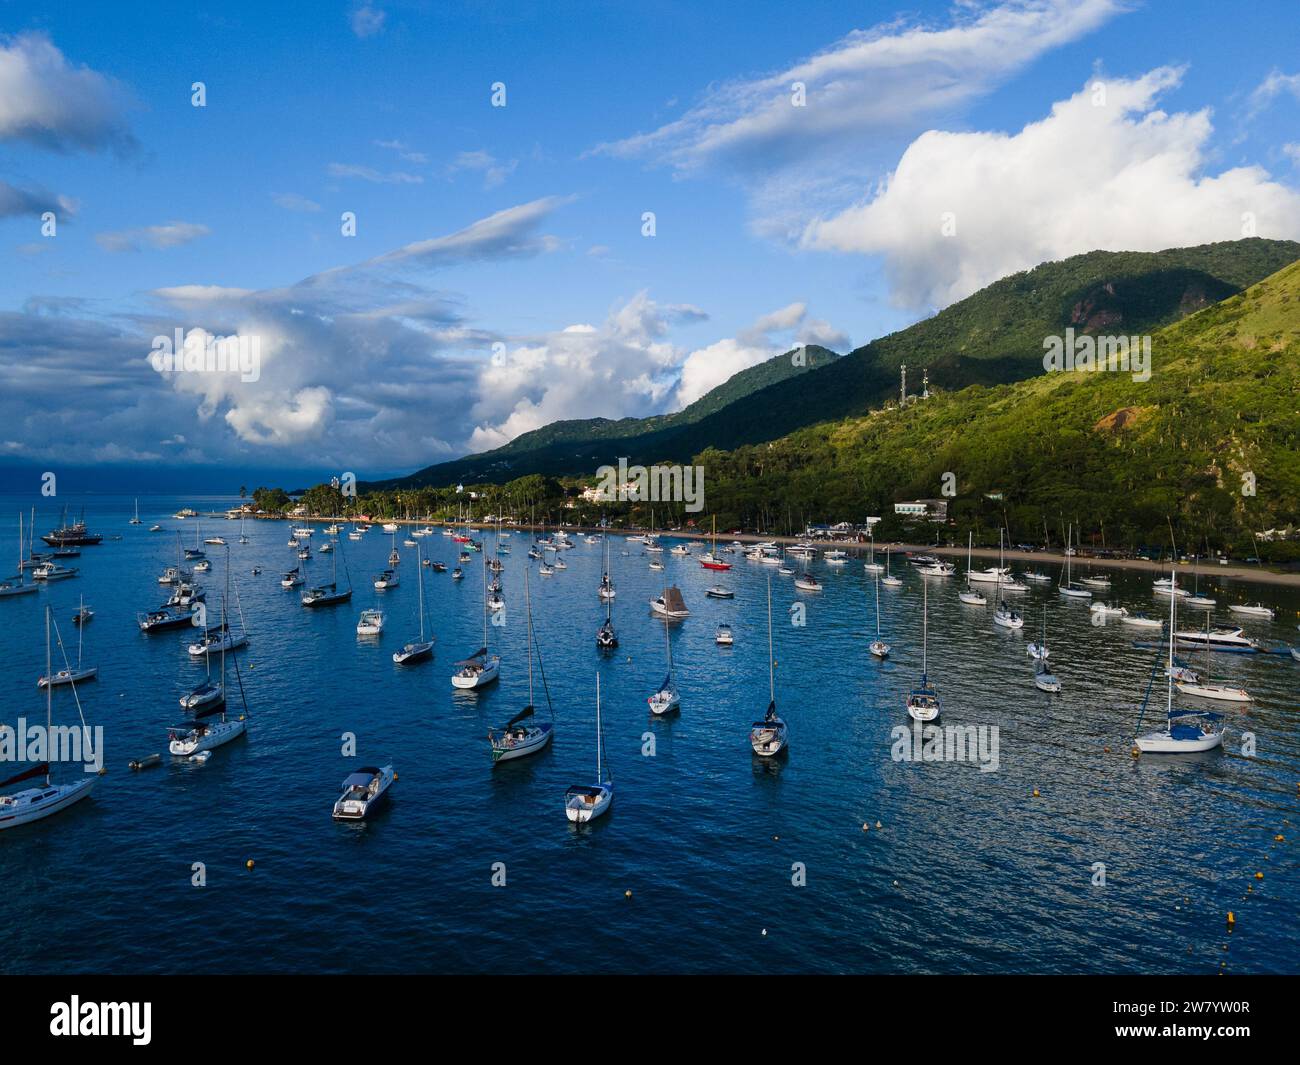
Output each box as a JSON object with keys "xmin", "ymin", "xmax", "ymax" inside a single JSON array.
[{"xmin": 0, "ymin": 0, "xmax": 1300, "ymax": 486}]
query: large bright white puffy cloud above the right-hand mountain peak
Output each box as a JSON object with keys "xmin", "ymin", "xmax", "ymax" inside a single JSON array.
[{"xmin": 802, "ymin": 68, "xmax": 1300, "ymax": 308}]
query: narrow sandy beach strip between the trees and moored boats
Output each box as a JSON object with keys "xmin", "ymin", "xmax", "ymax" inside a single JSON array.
[{"xmin": 231, "ymin": 514, "xmax": 1300, "ymax": 588}]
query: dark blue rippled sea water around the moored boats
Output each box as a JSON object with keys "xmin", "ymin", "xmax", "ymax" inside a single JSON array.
[{"xmin": 0, "ymin": 497, "xmax": 1300, "ymax": 973}]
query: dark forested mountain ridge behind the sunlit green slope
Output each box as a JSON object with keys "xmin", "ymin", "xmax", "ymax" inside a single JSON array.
[{"xmin": 376, "ymin": 238, "xmax": 1300, "ymax": 488}]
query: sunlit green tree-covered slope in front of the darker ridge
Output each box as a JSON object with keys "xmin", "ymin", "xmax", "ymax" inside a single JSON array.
[{"xmin": 696, "ymin": 253, "xmax": 1300, "ymax": 546}]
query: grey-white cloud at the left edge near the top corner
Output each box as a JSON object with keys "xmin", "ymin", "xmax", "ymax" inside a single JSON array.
[{"xmin": 0, "ymin": 33, "xmax": 135, "ymax": 152}]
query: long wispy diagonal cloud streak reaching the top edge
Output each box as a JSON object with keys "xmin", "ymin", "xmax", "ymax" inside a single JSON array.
[{"xmin": 595, "ymin": 0, "xmax": 1122, "ymax": 172}]
